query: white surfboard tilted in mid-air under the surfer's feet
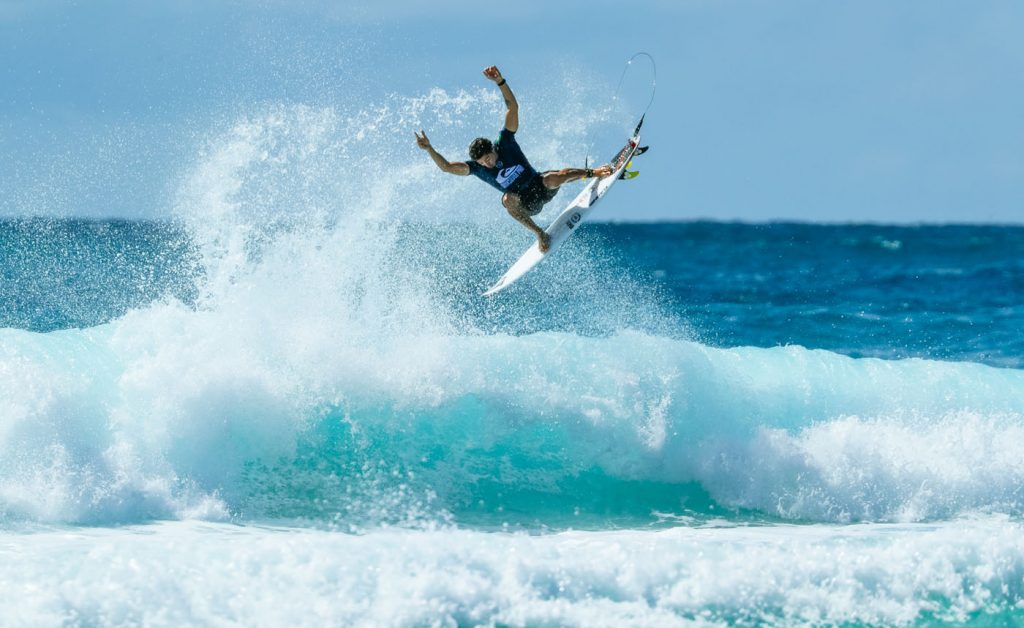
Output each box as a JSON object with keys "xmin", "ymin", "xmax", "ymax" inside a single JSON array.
[{"xmin": 483, "ymin": 114, "xmax": 647, "ymax": 296}]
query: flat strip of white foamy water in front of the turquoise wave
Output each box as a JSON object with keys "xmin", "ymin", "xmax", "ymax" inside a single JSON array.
[{"xmin": 0, "ymin": 517, "xmax": 1024, "ymax": 626}]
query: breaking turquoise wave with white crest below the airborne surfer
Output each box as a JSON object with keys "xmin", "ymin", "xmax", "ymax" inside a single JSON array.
[{"xmin": 0, "ymin": 323, "xmax": 1024, "ymax": 526}]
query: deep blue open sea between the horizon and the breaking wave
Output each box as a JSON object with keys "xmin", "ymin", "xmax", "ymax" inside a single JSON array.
[{"xmin": 6, "ymin": 218, "xmax": 1024, "ymax": 369}]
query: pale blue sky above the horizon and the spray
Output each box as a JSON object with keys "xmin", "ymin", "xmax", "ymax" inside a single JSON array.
[{"xmin": 0, "ymin": 0, "xmax": 1024, "ymax": 222}]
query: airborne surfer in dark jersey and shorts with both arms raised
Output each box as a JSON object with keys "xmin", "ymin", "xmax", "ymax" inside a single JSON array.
[{"xmin": 416, "ymin": 66, "xmax": 611, "ymax": 252}]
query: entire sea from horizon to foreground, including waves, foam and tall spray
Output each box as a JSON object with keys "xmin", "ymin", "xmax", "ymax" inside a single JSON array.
[{"xmin": 0, "ymin": 100, "xmax": 1024, "ymax": 626}]
